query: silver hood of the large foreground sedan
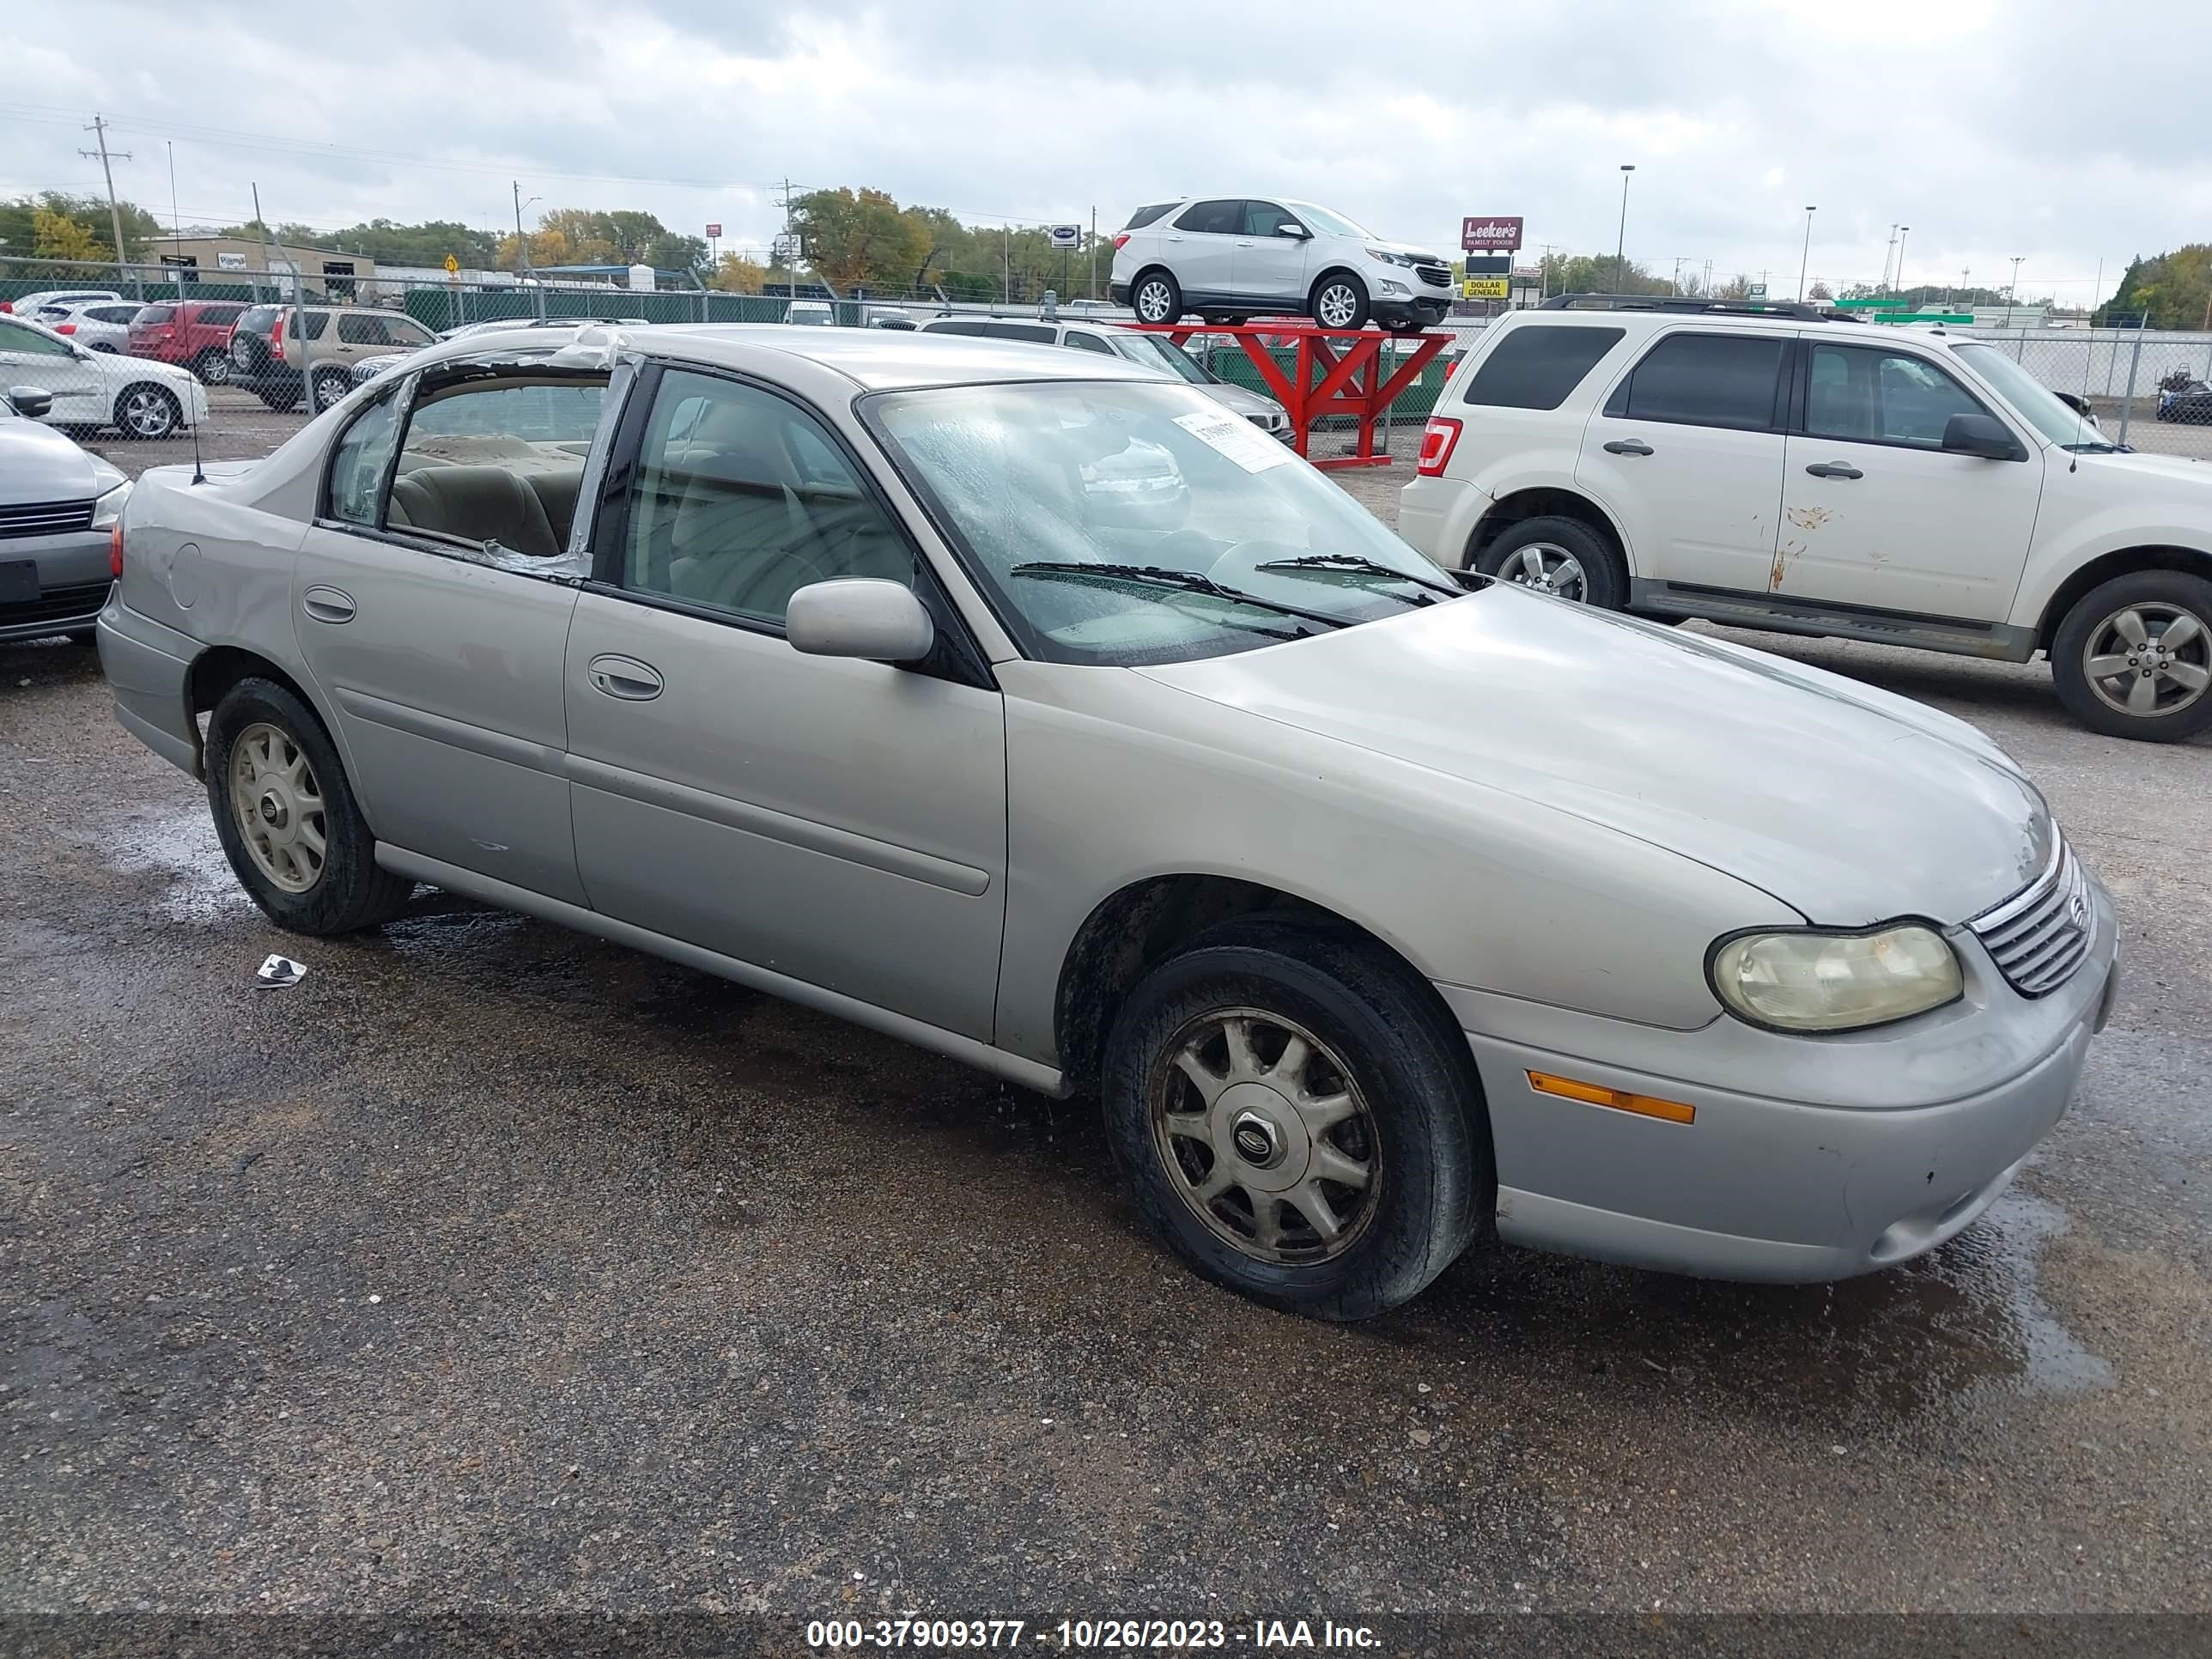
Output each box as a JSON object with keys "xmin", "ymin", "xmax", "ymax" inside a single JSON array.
[{"xmin": 1137, "ymin": 584, "xmax": 2053, "ymax": 927}]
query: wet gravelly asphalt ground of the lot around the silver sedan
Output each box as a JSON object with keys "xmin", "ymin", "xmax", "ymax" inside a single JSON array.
[{"xmin": 0, "ymin": 409, "xmax": 2212, "ymax": 1621}]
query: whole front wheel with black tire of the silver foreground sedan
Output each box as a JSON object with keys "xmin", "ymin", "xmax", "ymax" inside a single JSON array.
[{"xmin": 1102, "ymin": 915, "xmax": 1493, "ymax": 1318}]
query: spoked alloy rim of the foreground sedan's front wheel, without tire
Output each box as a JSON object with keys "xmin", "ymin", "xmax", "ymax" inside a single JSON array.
[{"xmin": 1151, "ymin": 1009, "xmax": 1382, "ymax": 1265}]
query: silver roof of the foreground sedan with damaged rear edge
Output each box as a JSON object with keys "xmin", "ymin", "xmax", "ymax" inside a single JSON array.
[{"xmin": 420, "ymin": 323, "xmax": 1159, "ymax": 392}]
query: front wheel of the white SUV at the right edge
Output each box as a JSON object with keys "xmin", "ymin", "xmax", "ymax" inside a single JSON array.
[{"xmin": 2051, "ymin": 571, "xmax": 2212, "ymax": 744}]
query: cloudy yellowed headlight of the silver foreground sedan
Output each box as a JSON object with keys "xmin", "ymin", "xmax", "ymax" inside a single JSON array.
[{"xmin": 1708, "ymin": 922, "xmax": 1964, "ymax": 1030}]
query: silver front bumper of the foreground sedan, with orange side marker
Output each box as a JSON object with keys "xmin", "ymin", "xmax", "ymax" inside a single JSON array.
[{"xmin": 1440, "ymin": 890, "xmax": 2119, "ymax": 1283}]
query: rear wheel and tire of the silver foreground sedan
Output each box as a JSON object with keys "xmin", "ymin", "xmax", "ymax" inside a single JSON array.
[{"xmin": 206, "ymin": 679, "xmax": 414, "ymax": 938}]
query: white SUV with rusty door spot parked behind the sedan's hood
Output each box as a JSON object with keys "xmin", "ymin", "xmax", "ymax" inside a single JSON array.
[{"xmin": 1398, "ymin": 296, "xmax": 2212, "ymax": 741}]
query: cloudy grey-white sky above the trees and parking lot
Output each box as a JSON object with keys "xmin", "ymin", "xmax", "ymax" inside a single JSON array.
[{"xmin": 0, "ymin": 0, "xmax": 2212, "ymax": 303}]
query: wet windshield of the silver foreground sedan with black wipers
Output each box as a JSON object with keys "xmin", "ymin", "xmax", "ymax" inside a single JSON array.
[{"xmin": 863, "ymin": 380, "xmax": 1460, "ymax": 665}]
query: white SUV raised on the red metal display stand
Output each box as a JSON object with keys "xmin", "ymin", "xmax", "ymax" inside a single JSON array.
[{"xmin": 1110, "ymin": 197, "xmax": 1451, "ymax": 334}]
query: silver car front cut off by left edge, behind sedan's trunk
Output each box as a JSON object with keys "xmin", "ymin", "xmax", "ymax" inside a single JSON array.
[{"xmin": 0, "ymin": 387, "xmax": 131, "ymax": 641}]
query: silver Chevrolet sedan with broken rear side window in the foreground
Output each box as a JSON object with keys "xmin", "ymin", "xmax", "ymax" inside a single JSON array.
[{"xmin": 100, "ymin": 327, "xmax": 2117, "ymax": 1318}]
